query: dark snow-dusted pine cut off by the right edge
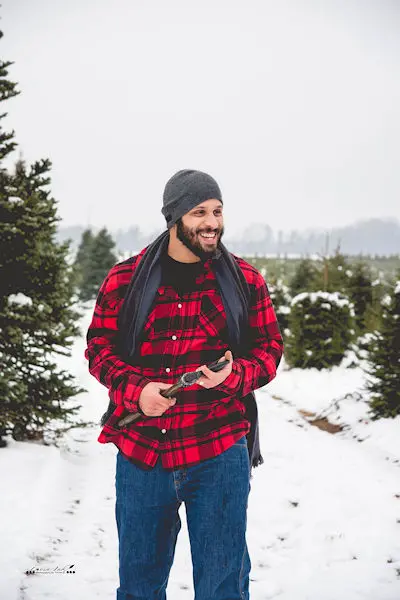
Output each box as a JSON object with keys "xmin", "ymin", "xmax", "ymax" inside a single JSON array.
[{"xmin": 366, "ymin": 280, "xmax": 400, "ymax": 419}]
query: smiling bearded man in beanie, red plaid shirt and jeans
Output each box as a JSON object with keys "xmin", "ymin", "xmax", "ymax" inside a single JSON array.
[{"xmin": 86, "ymin": 170, "xmax": 283, "ymax": 600}]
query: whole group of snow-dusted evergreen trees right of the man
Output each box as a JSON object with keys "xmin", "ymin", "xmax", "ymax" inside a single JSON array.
[{"xmin": 264, "ymin": 251, "xmax": 400, "ymax": 418}]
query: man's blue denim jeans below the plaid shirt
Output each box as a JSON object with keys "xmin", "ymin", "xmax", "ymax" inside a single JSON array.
[{"xmin": 115, "ymin": 436, "xmax": 251, "ymax": 600}]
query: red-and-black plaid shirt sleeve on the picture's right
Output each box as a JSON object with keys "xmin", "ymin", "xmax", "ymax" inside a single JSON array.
[{"xmin": 215, "ymin": 271, "xmax": 283, "ymax": 397}]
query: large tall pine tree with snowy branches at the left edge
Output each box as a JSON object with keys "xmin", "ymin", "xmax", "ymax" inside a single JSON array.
[{"xmin": 0, "ymin": 34, "xmax": 82, "ymax": 440}]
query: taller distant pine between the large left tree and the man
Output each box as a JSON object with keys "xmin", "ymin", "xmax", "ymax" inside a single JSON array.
[{"xmin": 79, "ymin": 228, "xmax": 117, "ymax": 302}]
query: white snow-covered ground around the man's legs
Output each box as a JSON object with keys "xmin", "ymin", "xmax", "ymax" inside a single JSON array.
[{"xmin": 0, "ymin": 314, "xmax": 400, "ymax": 600}]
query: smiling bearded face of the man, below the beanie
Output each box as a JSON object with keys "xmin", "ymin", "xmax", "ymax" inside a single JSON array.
[{"xmin": 176, "ymin": 200, "xmax": 224, "ymax": 261}]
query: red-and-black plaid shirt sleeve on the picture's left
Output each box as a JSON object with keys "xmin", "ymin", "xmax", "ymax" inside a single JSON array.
[{"xmin": 85, "ymin": 265, "xmax": 149, "ymax": 412}]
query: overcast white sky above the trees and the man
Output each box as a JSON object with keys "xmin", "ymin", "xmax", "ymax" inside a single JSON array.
[{"xmin": 0, "ymin": 0, "xmax": 400, "ymax": 234}]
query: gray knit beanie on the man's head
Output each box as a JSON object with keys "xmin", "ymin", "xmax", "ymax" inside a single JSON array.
[{"xmin": 161, "ymin": 169, "xmax": 222, "ymax": 229}]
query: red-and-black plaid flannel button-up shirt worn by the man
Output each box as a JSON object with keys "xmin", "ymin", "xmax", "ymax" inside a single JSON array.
[{"xmin": 85, "ymin": 250, "xmax": 283, "ymax": 469}]
